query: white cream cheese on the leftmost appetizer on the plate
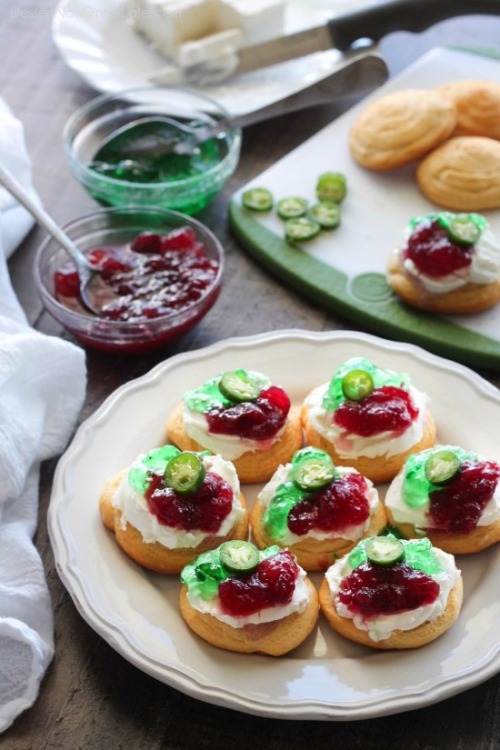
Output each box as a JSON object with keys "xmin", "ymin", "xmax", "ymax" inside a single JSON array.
[{"xmin": 113, "ymin": 456, "xmax": 245, "ymax": 549}]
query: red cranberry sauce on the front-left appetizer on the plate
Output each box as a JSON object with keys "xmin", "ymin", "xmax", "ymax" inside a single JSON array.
[{"xmin": 219, "ymin": 550, "xmax": 299, "ymax": 617}]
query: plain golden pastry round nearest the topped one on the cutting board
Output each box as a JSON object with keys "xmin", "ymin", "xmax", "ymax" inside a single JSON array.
[{"xmin": 417, "ymin": 136, "xmax": 500, "ymax": 211}]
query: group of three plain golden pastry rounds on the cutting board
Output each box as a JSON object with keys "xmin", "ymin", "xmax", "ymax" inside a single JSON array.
[{"xmin": 349, "ymin": 80, "xmax": 500, "ymax": 211}]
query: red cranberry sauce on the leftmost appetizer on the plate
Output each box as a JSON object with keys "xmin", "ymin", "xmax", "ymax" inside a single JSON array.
[{"xmin": 146, "ymin": 471, "xmax": 233, "ymax": 534}]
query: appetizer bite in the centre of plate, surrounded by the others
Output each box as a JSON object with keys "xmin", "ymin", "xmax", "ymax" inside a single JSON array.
[{"xmin": 250, "ymin": 448, "xmax": 386, "ymax": 571}]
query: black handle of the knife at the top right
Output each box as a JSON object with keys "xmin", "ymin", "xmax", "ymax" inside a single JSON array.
[{"xmin": 328, "ymin": 0, "xmax": 500, "ymax": 51}]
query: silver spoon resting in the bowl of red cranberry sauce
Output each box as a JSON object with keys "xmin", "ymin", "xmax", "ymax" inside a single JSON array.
[{"xmin": 0, "ymin": 164, "xmax": 100, "ymax": 315}]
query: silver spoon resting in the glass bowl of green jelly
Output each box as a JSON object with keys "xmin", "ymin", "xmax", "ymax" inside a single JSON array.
[{"xmin": 95, "ymin": 54, "xmax": 388, "ymax": 161}]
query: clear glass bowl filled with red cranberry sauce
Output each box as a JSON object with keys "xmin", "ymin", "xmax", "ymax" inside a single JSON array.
[{"xmin": 34, "ymin": 206, "xmax": 224, "ymax": 354}]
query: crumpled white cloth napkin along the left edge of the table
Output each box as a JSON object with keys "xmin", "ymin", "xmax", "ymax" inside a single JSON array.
[{"xmin": 0, "ymin": 99, "xmax": 86, "ymax": 732}]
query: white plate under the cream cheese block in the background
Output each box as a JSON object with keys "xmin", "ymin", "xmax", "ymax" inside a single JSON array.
[{"xmin": 52, "ymin": 0, "xmax": 356, "ymax": 115}]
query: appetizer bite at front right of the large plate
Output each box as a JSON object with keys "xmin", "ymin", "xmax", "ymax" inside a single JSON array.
[{"xmin": 319, "ymin": 534, "xmax": 463, "ymax": 649}]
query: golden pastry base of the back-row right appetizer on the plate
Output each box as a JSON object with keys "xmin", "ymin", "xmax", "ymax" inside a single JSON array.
[{"xmin": 301, "ymin": 404, "xmax": 436, "ymax": 484}]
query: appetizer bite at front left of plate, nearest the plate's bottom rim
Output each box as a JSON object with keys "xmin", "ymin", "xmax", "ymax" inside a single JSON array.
[{"xmin": 180, "ymin": 541, "xmax": 319, "ymax": 656}]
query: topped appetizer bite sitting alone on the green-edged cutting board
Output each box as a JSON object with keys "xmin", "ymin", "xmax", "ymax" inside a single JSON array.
[{"xmin": 387, "ymin": 211, "xmax": 500, "ymax": 315}]
